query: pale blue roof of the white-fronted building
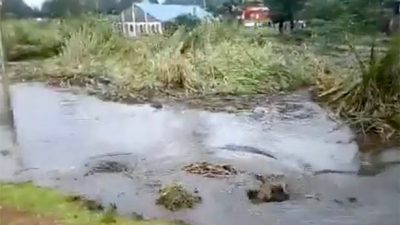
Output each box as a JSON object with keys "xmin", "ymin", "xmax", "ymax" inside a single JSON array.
[{"xmin": 135, "ymin": 3, "xmax": 211, "ymax": 22}]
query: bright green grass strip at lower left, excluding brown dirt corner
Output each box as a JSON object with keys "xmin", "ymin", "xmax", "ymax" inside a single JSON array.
[{"xmin": 0, "ymin": 184, "xmax": 172, "ymax": 225}]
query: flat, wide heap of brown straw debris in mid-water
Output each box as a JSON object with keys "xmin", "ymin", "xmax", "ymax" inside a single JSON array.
[{"xmin": 183, "ymin": 162, "xmax": 238, "ymax": 178}]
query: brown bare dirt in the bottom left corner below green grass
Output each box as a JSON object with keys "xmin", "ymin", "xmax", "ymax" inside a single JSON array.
[{"xmin": 0, "ymin": 206, "xmax": 60, "ymax": 225}]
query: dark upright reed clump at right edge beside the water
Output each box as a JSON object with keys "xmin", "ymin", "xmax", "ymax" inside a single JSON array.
[{"xmin": 319, "ymin": 36, "xmax": 400, "ymax": 139}]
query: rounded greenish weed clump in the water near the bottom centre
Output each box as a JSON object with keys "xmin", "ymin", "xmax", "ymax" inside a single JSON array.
[{"xmin": 156, "ymin": 184, "xmax": 201, "ymax": 211}]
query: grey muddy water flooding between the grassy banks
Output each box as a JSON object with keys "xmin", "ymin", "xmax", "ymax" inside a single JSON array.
[{"xmin": 2, "ymin": 84, "xmax": 400, "ymax": 225}]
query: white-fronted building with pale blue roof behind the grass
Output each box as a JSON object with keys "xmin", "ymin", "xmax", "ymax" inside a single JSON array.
[{"xmin": 115, "ymin": 2, "xmax": 211, "ymax": 37}]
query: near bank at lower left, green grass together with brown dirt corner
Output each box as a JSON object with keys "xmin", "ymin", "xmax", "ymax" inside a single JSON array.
[{"xmin": 0, "ymin": 184, "xmax": 173, "ymax": 225}]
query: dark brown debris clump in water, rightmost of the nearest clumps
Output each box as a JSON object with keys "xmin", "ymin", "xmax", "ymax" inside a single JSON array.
[{"xmin": 247, "ymin": 175, "xmax": 290, "ymax": 204}]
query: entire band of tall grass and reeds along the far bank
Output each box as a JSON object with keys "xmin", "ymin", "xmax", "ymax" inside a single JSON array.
[{"xmin": 3, "ymin": 19, "xmax": 400, "ymax": 138}]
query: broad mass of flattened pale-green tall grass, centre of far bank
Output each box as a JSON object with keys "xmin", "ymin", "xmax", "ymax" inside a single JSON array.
[{"xmin": 54, "ymin": 19, "xmax": 320, "ymax": 95}]
